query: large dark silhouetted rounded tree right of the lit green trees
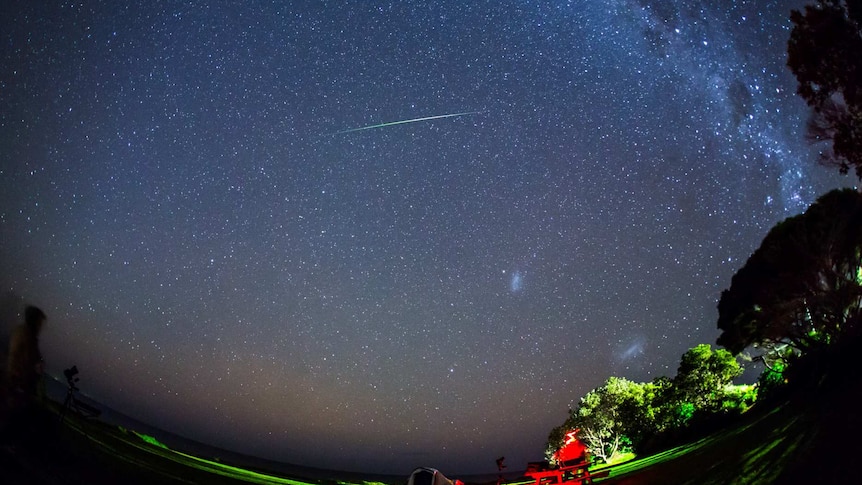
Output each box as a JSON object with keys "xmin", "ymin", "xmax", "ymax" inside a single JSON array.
[{"xmin": 718, "ymin": 189, "xmax": 862, "ymax": 354}]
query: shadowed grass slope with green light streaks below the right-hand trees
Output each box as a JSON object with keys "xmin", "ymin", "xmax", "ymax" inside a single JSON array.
[{"xmin": 600, "ymin": 358, "xmax": 862, "ymax": 485}]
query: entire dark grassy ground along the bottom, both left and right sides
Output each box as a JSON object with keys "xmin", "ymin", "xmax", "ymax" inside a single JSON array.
[{"xmin": 0, "ymin": 366, "xmax": 862, "ymax": 485}]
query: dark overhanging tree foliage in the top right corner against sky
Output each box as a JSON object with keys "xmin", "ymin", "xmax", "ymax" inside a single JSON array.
[{"xmin": 787, "ymin": 0, "xmax": 862, "ymax": 179}]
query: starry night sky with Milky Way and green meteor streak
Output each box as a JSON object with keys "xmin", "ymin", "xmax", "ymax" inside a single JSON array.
[{"xmin": 0, "ymin": 0, "xmax": 854, "ymax": 476}]
